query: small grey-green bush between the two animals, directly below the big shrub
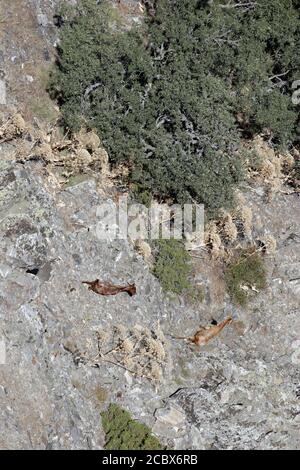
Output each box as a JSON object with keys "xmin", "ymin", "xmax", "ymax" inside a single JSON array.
[{"xmin": 153, "ymin": 239, "xmax": 191, "ymax": 294}]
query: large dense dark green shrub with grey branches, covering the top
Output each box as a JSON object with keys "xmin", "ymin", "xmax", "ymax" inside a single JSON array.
[{"xmin": 50, "ymin": 0, "xmax": 300, "ymax": 213}]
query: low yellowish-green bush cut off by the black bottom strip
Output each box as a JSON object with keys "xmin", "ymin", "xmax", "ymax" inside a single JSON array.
[{"xmin": 101, "ymin": 403, "xmax": 163, "ymax": 450}]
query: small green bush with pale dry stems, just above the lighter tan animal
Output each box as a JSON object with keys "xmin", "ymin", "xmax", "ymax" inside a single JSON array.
[{"xmin": 225, "ymin": 248, "xmax": 267, "ymax": 307}]
